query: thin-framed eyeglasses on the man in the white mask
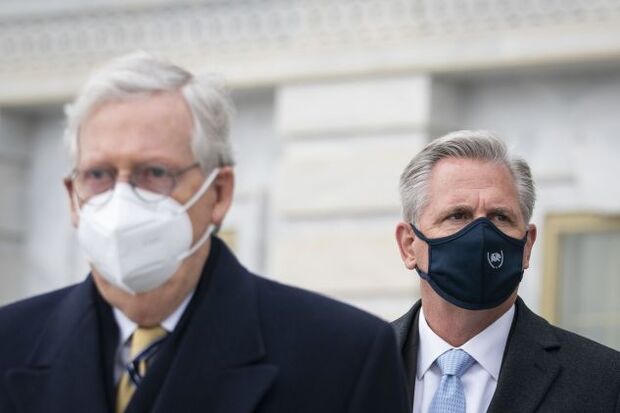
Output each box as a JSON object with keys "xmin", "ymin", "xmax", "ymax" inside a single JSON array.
[{"xmin": 69, "ymin": 162, "xmax": 200, "ymax": 205}]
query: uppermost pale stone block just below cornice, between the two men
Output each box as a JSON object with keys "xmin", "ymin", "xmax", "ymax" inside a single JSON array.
[{"xmin": 276, "ymin": 76, "xmax": 431, "ymax": 137}]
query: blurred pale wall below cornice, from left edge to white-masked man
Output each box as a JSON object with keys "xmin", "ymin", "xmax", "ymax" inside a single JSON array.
[{"xmin": 0, "ymin": 107, "xmax": 88, "ymax": 304}]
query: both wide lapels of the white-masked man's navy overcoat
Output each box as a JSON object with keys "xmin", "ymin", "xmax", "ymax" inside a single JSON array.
[{"xmin": 5, "ymin": 238, "xmax": 277, "ymax": 413}]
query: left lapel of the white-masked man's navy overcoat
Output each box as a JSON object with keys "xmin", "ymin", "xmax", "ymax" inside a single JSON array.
[{"xmin": 6, "ymin": 278, "xmax": 108, "ymax": 413}]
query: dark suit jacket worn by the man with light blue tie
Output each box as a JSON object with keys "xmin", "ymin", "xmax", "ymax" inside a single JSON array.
[{"xmin": 393, "ymin": 298, "xmax": 620, "ymax": 413}]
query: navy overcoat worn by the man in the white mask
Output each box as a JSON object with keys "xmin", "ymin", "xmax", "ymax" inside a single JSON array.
[{"xmin": 0, "ymin": 239, "xmax": 408, "ymax": 413}]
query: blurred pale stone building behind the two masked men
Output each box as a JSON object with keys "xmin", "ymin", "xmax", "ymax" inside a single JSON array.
[{"xmin": 0, "ymin": 0, "xmax": 620, "ymax": 349}]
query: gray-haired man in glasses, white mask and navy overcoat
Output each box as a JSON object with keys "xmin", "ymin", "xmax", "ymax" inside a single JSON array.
[{"xmin": 0, "ymin": 53, "xmax": 408, "ymax": 413}]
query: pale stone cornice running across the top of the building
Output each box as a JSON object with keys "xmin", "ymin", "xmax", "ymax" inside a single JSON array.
[{"xmin": 0, "ymin": 0, "xmax": 620, "ymax": 105}]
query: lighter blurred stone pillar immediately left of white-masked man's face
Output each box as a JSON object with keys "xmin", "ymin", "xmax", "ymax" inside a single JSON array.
[{"xmin": 24, "ymin": 105, "xmax": 89, "ymax": 295}]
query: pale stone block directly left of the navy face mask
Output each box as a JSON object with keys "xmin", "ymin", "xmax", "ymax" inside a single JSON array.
[{"xmin": 268, "ymin": 219, "xmax": 417, "ymax": 297}]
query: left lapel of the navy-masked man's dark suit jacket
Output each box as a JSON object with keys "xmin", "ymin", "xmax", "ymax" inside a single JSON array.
[{"xmin": 392, "ymin": 300, "xmax": 422, "ymax": 401}]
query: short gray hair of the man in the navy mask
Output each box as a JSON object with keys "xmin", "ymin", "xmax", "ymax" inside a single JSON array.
[{"xmin": 400, "ymin": 130, "xmax": 536, "ymax": 223}]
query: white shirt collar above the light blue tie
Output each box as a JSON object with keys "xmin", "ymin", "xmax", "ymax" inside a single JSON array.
[{"xmin": 416, "ymin": 305, "xmax": 515, "ymax": 381}]
